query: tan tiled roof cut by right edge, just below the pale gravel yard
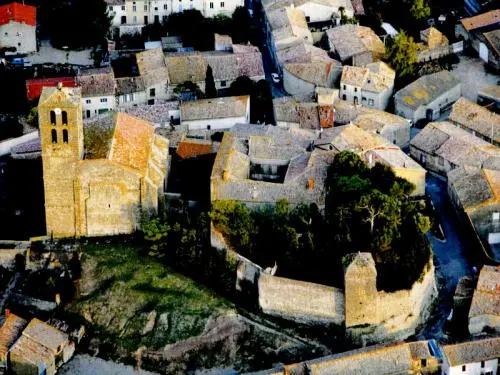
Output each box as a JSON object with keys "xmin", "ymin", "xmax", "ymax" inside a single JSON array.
[{"xmin": 449, "ymin": 97, "xmax": 500, "ymax": 142}]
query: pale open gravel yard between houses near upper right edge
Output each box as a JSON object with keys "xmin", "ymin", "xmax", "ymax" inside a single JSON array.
[{"xmin": 451, "ymin": 55, "xmax": 500, "ymax": 102}]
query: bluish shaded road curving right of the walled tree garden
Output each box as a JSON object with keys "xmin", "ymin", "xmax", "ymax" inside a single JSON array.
[{"xmin": 418, "ymin": 173, "xmax": 473, "ymax": 339}]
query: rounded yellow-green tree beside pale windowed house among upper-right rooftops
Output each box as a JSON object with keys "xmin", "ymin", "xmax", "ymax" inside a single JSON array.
[{"xmin": 386, "ymin": 31, "xmax": 418, "ymax": 77}]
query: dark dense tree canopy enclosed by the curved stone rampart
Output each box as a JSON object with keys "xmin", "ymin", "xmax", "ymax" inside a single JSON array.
[{"xmin": 211, "ymin": 152, "xmax": 430, "ymax": 291}]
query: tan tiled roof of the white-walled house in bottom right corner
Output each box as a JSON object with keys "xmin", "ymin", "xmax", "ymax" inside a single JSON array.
[{"xmin": 442, "ymin": 337, "xmax": 500, "ymax": 366}]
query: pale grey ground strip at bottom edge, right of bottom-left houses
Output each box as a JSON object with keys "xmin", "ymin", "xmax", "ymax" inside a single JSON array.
[{"xmin": 59, "ymin": 354, "xmax": 157, "ymax": 375}]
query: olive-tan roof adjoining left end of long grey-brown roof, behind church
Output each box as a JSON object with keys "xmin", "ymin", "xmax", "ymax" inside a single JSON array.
[{"xmin": 165, "ymin": 52, "xmax": 207, "ymax": 85}]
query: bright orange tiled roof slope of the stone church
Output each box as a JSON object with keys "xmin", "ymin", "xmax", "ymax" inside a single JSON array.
[{"xmin": 109, "ymin": 112, "xmax": 154, "ymax": 173}]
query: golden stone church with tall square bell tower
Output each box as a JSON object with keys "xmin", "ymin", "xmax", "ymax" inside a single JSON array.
[{"xmin": 38, "ymin": 85, "xmax": 168, "ymax": 237}]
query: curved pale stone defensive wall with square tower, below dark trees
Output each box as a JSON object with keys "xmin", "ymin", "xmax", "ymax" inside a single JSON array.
[{"xmin": 211, "ymin": 226, "xmax": 437, "ymax": 346}]
